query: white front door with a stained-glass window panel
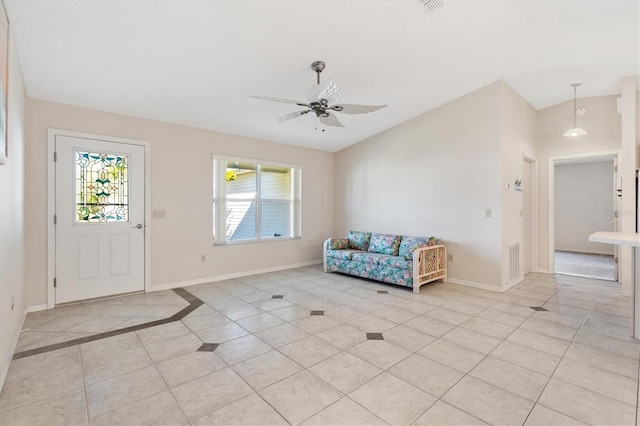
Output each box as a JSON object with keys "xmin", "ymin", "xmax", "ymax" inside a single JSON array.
[{"xmin": 55, "ymin": 135, "xmax": 145, "ymax": 303}]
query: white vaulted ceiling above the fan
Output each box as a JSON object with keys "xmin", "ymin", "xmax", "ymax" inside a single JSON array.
[{"xmin": 4, "ymin": 0, "xmax": 640, "ymax": 151}]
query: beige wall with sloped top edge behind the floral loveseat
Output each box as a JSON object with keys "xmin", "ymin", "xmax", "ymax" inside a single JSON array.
[{"xmin": 336, "ymin": 82, "xmax": 504, "ymax": 289}]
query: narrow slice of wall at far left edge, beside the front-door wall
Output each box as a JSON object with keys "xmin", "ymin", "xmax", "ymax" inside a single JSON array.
[{"xmin": 0, "ymin": 35, "xmax": 27, "ymax": 390}]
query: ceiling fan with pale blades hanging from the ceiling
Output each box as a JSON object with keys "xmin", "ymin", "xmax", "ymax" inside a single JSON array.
[{"xmin": 251, "ymin": 61, "xmax": 386, "ymax": 131}]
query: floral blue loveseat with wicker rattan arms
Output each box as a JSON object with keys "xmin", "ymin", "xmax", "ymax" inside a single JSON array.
[{"xmin": 322, "ymin": 231, "xmax": 447, "ymax": 293}]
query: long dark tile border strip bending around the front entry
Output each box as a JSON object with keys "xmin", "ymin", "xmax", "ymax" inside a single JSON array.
[{"xmin": 13, "ymin": 288, "xmax": 205, "ymax": 359}]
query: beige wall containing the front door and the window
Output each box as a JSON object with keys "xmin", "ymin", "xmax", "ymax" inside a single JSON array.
[{"xmin": 26, "ymin": 99, "xmax": 335, "ymax": 305}]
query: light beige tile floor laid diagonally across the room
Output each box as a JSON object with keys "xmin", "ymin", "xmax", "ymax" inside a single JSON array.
[{"xmin": 0, "ymin": 267, "xmax": 640, "ymax": 425}]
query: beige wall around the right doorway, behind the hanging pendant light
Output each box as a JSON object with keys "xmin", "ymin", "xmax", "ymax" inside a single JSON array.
[{"xmin": 536, "ymin": 96, "xmax": 621, "ymax": 272}]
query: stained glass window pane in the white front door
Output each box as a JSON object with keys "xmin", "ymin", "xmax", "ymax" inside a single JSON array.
[{"xmin": 75, "ymin": 151, "xmax": 129, "ymax": 223}]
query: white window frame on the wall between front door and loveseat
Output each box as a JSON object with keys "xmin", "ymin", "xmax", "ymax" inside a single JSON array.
[{"xmin": 212, "ymin": 154, "xmax": 302, "ymax": 246}]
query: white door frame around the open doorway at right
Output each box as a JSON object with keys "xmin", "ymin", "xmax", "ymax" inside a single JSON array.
[{"xmin": 547, "ymin": 150, "xmax": 621, "ymax": 276}]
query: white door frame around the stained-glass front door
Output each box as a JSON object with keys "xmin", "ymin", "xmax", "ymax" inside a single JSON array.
[{"xmin": 47, "ymin": 128, "xmax": 151, "ymax": 309}]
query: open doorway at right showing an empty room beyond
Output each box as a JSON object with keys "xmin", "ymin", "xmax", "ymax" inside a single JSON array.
[{"xmin": 549, "ymin": 153, "xmax": 619, "ymax": 281}]
